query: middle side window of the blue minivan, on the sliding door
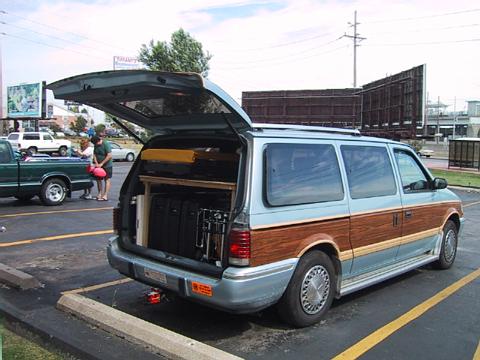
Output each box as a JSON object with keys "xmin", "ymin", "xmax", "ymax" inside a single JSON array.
[{"xmin": 341, "ymin": 145, "xmax": 397, "ymax": 199}]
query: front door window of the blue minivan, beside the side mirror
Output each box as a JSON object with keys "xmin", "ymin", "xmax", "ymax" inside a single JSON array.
[{"xmin": 395, "ymin": 149, "xmax": 429, "ymax": 193}]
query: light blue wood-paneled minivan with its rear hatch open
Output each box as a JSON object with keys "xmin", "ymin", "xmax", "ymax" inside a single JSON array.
[{"xmin": 48, "ymin": 71, "xmax": 464, "ymax": 327}]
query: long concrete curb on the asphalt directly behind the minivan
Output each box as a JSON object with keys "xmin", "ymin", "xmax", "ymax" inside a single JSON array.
[{"xmin": 57, "ymin": 294, "xmax": 241, "ymax": 360}]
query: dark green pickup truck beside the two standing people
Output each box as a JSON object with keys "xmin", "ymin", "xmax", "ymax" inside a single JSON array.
[{"xmin": 0, "ymin": 140, "xmax": 93, "ymax": 206}]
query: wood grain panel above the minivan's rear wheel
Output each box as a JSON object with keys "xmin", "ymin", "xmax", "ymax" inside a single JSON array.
[{"xmin": 250, "ymin": 218, "xmax": 351, "ymax": 266}]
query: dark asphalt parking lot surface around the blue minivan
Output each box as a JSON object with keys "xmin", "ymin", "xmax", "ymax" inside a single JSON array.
[{"xmin": 0, "ymin": 163, "xmax": 480, "ymax": 360}]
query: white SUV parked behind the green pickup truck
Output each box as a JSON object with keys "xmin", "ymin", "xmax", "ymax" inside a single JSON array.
[{"xmin": 7, "ymin": 131, "xmax": 72, "ymax": 156}]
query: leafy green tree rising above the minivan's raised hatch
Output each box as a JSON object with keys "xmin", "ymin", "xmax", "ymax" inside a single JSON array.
[{"xmin": 138, "ymin": 29, "xmax": 212, "ymax": 76}]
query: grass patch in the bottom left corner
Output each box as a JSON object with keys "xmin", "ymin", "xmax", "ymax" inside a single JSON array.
[{"xmin": 0, "ymin": 324, "xmax": 64, "ymax": 360}]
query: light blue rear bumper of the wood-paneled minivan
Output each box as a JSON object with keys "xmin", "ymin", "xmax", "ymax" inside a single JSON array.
[{"xmin": 107, "ymin": 237, "xmax": 298, "ymax": 313}]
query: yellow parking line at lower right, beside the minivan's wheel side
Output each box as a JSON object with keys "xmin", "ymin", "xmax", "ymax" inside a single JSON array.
[{"xmin": 333, "ymin": 268, "xmax": 480, "ymax": 360}]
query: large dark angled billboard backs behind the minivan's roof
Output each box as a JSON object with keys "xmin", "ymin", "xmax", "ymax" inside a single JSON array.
[{"xmin": 242, "ymin": 65, "xmax": 426, "ymax": 139}]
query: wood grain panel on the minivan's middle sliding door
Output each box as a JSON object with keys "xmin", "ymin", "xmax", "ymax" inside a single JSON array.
[{"xmin": 350, "ymin": 210, "xmax": 402, "ymax": 250}]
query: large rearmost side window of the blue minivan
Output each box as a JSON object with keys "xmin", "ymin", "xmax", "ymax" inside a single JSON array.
[{"xmin": 264, "ymin": 144, "xmax": 344, "ymax": 206}]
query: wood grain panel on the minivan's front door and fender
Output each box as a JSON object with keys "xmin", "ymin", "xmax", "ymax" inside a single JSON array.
[{"xmin": 402, "ymin": 203, "xmax": 461, "ymax": 236}]
